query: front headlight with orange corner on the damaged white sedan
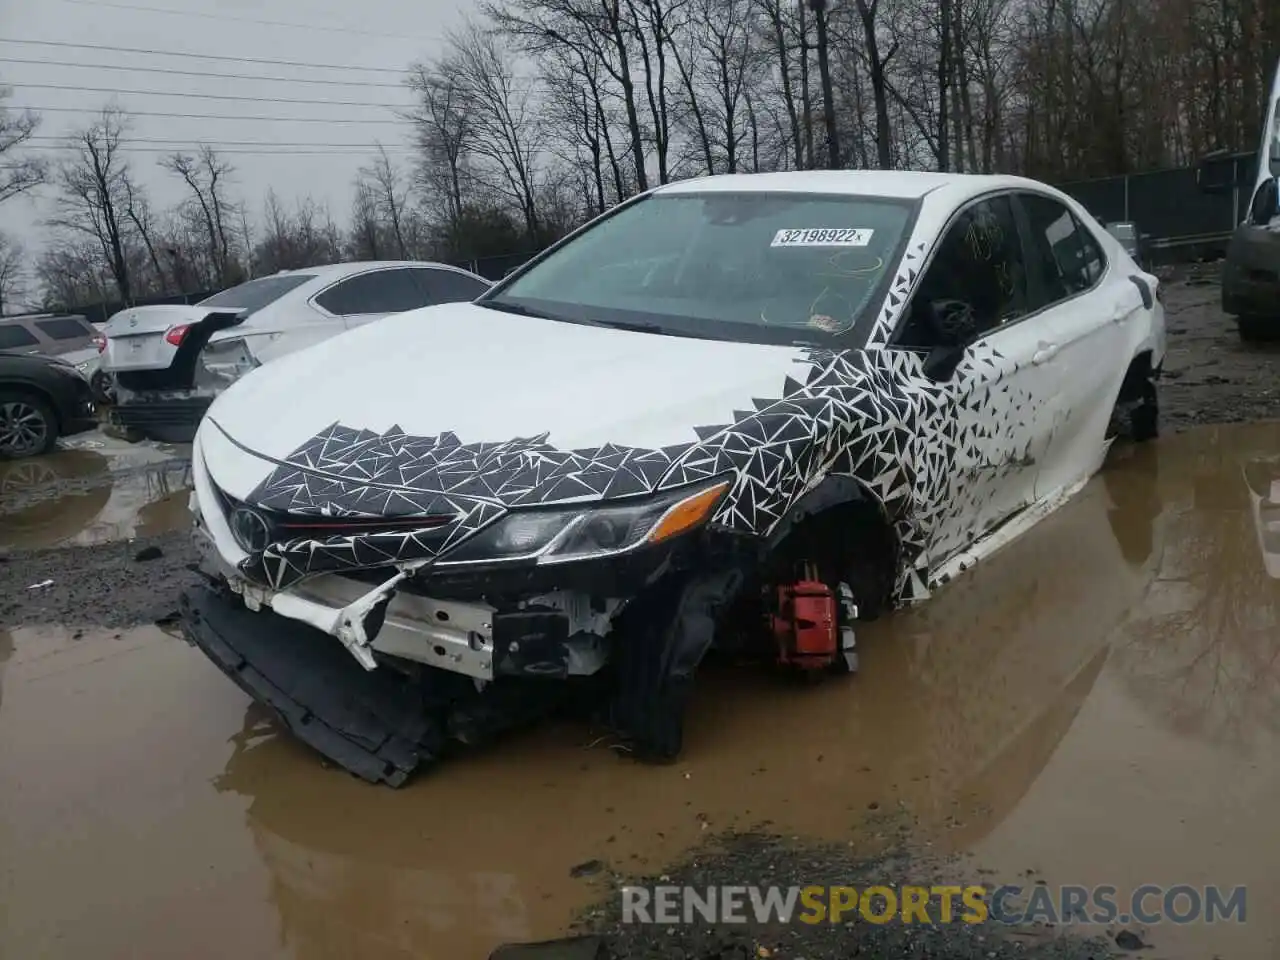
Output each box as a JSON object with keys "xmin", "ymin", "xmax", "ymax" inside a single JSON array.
[{"xmin": 436, "ymin": 480, "xmax": 730, "ymax": 566}]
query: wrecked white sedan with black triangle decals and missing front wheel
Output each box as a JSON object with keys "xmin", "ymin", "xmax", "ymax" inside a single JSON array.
[{"xmin": 183, "ymin": 172, "xmax": 1165, "ymax": 785}]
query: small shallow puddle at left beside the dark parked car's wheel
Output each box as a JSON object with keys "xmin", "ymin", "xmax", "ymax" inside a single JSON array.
[{"xmin": 0, "ymin": 434, "xmax": 191, "ymax": 549}]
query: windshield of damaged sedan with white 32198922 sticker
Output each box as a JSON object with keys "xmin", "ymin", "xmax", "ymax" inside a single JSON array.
[{"xmin": 479, "ymin": 192, "xmax": 915, "ymax": 347}]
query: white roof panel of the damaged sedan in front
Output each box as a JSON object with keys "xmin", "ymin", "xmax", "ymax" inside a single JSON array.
[{"xmin": 654, "ymin": 170, "xmax": 1044, "ymax": 200}]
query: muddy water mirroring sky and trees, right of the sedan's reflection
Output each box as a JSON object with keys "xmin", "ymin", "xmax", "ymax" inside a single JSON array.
[{"xmin": 975, "ymin": 424, "xmax": 1280, "ymax": 957}]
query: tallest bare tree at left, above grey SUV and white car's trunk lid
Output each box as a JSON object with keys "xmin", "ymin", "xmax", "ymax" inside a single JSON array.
[{"xmin": 47, "ymin": 108, "xmax": 133, "ymax": 303}]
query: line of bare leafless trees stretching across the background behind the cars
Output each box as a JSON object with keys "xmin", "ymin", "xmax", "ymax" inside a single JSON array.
[{"xmin": 0, "ymin": 0, "xmax": 1280, "ymax": 312}]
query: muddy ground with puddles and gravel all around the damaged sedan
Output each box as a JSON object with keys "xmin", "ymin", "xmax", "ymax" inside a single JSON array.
[{"xmin": 0, "ymin": 268, "xmax": 1280, "ymax": 960}]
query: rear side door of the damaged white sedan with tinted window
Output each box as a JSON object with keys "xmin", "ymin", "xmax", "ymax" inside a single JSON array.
[{"xmin": 1016, "ymin": 191, "xmax": 1146, "ymax": 499}]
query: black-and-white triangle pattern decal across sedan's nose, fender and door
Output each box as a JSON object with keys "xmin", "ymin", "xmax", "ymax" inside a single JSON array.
[{"xmin": 241, "ymin": 244, "xmax": 1043, "ymax": 599}]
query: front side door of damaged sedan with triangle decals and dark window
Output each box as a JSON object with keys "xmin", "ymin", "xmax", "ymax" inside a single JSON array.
[{"xmin": 891, "ymin": 193, "xmax": 1046, "ymax": 567}]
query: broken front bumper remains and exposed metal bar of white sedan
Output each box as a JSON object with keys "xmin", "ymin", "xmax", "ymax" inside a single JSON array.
[{"xmin": 182, "ymin": 478, "xmax": 732, "ymax": 786}]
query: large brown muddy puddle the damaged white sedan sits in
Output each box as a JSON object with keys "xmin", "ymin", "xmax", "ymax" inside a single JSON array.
[{"xmin": 0, "ymin": 424, "xmax": 1280, "ymax": 957}]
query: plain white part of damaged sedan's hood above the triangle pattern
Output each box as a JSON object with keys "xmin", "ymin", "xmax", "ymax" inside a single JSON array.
[{"xmin": 201, "ymin": 303, "xmax": 812, "ymax": 498}]
